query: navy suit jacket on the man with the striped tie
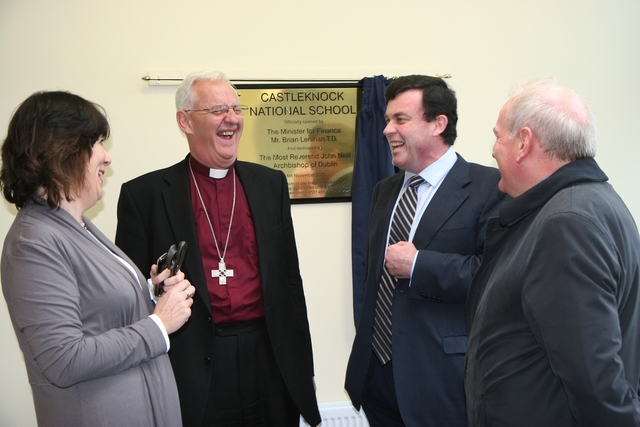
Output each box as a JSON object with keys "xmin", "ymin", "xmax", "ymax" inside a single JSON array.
[{"xmin": 345, "ymin": 156, "xmax": 504, "ymax": 427}]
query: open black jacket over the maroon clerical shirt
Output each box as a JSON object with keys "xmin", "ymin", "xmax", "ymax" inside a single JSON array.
[{"xmin": 115, "ymin": 156, "xmax": 320, "ymax": 427}]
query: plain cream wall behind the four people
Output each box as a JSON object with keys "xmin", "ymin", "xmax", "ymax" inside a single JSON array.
[{"xmin": 0, "ymin": 0, "xmax": 640, "ymax": 427}]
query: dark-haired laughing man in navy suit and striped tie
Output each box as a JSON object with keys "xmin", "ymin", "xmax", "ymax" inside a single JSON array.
[{"xmin": 345, "ymin": 76, "xmax": 503, "ymax": 427}]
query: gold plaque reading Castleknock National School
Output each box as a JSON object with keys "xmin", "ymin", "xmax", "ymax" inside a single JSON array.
[{"xmin": 236, "ymin": 84, "xmax": 361, "ymax": 203}]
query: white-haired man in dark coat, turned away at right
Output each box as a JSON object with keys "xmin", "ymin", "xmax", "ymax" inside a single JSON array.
[{"xmin": 465, "ymin": 81, "xmax": 640, "ymax": 427}]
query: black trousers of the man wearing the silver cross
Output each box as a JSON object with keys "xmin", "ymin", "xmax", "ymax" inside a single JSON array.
[{"xmin": 203, "ymin": 319, "xmax": 300, "ymax": 427}]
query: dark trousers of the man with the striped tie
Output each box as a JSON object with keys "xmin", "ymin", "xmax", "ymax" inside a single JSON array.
[{"xmin": 362, "ymin": 351, "xmax": 405, "ymax": 427}]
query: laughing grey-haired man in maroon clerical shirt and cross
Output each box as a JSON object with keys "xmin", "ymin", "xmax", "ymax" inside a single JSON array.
[{"xmin": 116, "ymin": 72, "xmax": 320, "ymax": 427}]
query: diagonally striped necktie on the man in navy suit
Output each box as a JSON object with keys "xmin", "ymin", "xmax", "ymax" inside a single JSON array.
[{"xmin": 373, "ymin": 175, "xmax": 424, "ymax": 365}]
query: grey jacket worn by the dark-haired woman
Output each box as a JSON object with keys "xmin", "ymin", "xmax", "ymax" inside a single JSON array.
[{"xmin": 2, "ymin": 203, "xmax": 182, "ymax": 427}]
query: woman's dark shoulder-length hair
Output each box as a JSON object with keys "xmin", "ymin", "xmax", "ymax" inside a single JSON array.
[{"xmin": 0, "ymin": 91, "xmax": 109, "ymax": 209}]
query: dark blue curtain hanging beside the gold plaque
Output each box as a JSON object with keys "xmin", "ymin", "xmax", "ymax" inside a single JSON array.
[{"xmin": 351, "ymin": 76, "xmax": 396, "ymax": 325}]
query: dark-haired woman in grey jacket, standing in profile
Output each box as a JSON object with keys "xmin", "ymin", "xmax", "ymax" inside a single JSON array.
[{"xmin": 0, "ymin": 92, "xmax": 194, "ymax": 427}]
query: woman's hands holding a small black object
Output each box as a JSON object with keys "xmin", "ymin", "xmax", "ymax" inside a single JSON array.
[{"xmin": 151, "ymin": 276, "xmax": 196, "ymax": 334}]
